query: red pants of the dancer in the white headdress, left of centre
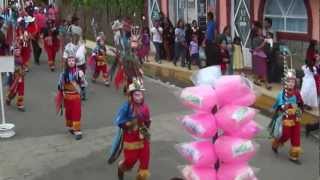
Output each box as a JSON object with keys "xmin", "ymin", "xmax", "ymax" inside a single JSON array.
[{"xmin": 64, "ymin": 93, "xmax": 81, "ymax": 131}]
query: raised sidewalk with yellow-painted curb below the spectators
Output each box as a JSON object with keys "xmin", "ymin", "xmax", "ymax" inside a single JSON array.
[{"xmin": 86, "ymin": 40, "xmax": 320, "ymax": 124}]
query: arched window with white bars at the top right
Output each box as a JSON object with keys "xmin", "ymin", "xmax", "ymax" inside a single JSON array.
[{"xmin": 264, "ymin": 0, "xmax": 308, "ymax": 34}]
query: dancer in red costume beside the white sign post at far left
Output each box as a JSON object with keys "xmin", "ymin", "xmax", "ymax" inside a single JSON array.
[{"xmin": 6, "ymin": 38, "xmax": 25, "ymax": 111}]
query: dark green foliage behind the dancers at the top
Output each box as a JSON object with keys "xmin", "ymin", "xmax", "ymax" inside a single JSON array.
[{"xmin": 59, "ymin": 0, "xmax": 145, "ymax": 41}]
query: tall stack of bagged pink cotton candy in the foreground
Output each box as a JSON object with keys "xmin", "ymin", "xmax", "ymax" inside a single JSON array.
[{"xmin": 176, "ymin": 67, "xmax": 261, "ymax": 180}]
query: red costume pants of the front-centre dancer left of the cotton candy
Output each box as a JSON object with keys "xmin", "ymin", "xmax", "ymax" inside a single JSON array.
[{"xmin": 120, "ymin": 131, "xmax": 150, "ymax": 179}]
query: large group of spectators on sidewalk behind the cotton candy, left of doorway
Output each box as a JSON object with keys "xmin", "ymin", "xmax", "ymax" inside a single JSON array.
[{"xmin": 132, "ymin": 13, "xmax": 244, "ymax": 74}]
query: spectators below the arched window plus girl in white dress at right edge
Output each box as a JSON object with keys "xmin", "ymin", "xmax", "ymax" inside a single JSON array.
[{"xmin": 251, "ymin": 18, "xmax": 320, "ymax": 110}]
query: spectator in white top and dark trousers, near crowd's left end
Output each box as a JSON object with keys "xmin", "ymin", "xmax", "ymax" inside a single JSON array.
[{"xmin": 151, "ymin": 21, "xmax": 163, "ymax": 64}]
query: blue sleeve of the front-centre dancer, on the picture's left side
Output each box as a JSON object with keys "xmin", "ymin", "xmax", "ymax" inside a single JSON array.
[{"xmin": 114, "ymin": 101, "xmax": 134, "ymax": 126}]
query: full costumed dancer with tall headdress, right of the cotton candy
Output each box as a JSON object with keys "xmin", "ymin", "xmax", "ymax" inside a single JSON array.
[{"xmin": 269, "ymin": 52, "xmax": 303, "ymax": 164}]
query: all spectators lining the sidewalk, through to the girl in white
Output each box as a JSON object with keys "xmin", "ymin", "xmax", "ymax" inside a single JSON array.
[{"xmin": 141, "ymin": 12, "xmax": 320, "ymax": 109}]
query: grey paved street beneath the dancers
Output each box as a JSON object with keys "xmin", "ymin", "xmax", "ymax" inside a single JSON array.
[{"xmin": 0, "ymin": 58, "xmax": 319, "ymax": 180}]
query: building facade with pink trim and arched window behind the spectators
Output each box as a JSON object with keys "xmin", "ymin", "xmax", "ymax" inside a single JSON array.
[{"xmin": 146, "ymin": 0, "xmax": 320, "ymax": 66}]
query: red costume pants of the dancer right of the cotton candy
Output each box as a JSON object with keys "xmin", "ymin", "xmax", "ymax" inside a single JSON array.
[{"xmin": 272, "ymin": 119, "xmax": 301, "ymax": 160}]
